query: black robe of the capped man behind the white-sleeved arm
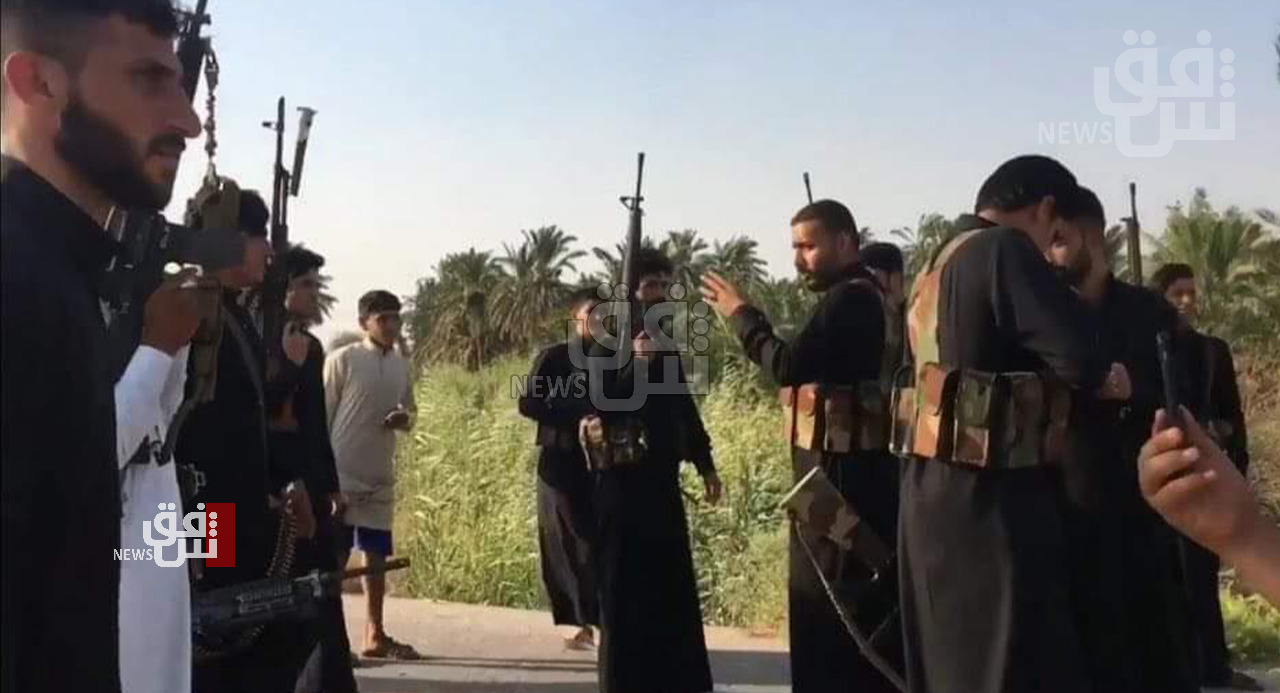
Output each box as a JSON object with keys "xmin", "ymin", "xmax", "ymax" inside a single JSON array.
[{"xmin": 174, "ymin": 293, "xmax": 315, "ymax": 693}]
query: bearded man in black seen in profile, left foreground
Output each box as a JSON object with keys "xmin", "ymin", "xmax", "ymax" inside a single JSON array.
[{"xmin": 0, "ymin": 1, "xmax": 200, "ymax": 693}]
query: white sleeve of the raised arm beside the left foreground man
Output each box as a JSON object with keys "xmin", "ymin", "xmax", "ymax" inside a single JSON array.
[{"xmin": 115, "ymin": 346, "xmax": 174, "ymax": 469}]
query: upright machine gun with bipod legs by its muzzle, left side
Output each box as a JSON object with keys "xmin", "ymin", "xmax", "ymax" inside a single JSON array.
[{"xmin": 262, "ymin": 96, "xmax": 316, "ymax": 377}]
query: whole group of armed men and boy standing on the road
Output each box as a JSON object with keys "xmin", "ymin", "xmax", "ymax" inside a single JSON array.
[{"xmin": 0, "ymin": 0, "xmax": 1274, "ymax": 693}]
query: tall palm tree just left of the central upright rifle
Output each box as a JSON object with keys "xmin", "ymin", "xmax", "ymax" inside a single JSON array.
[{"xmin": 493, "ymin": 225, "xmax": 586, "ymax": 347}]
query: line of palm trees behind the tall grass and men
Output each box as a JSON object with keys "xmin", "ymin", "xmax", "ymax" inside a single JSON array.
[{"xmin": 345, "ymin": 188, "xmax": 1280, "ymax": 369}]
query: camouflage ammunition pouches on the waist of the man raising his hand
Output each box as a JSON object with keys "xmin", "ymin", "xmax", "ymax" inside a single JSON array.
[{"xmin": 778, "ymin": 380, "xmax": 888, "ymax": 453}]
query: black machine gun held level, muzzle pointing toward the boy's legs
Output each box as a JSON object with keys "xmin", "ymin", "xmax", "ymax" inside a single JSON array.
[{"xmin": 191, "ymin": 558, "xmax": 408, "ymax": 642}]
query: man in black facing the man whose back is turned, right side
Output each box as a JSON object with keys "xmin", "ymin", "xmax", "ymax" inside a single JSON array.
[{"xmin": 1048, "ymin": 188, "xmax": 1199, "ymax": 693}]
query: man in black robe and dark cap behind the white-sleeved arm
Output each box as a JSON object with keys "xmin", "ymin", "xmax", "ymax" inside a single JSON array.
[{"xmin": 174, "ymin": 186, "xmax": 315, "ymax": 693}]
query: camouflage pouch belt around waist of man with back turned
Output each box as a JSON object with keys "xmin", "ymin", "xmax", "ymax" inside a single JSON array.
[{"xmin": 890, "ymin": 364, "xmax": 1071, "ymax": 469}]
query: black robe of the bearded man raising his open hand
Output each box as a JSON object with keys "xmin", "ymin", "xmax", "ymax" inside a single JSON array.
[{"xmin": 733, "ymin": 266, "xmax": 899, "ymax": 693}]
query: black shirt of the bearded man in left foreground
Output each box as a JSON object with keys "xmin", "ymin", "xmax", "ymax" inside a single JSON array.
[{"xmin": 0, "ymin": 156, "xmax": 120, "ymax": 693}]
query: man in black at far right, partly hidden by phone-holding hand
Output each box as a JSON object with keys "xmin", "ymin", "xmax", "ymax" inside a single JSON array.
[{"xmin": 1152, "ymin": 263, "xmax": 1262, "ymax": 690}]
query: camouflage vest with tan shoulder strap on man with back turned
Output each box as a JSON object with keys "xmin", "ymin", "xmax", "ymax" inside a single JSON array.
[{"xmin": 890, "ymin": 229, "xmax": 1070, "ymax": 469}]
